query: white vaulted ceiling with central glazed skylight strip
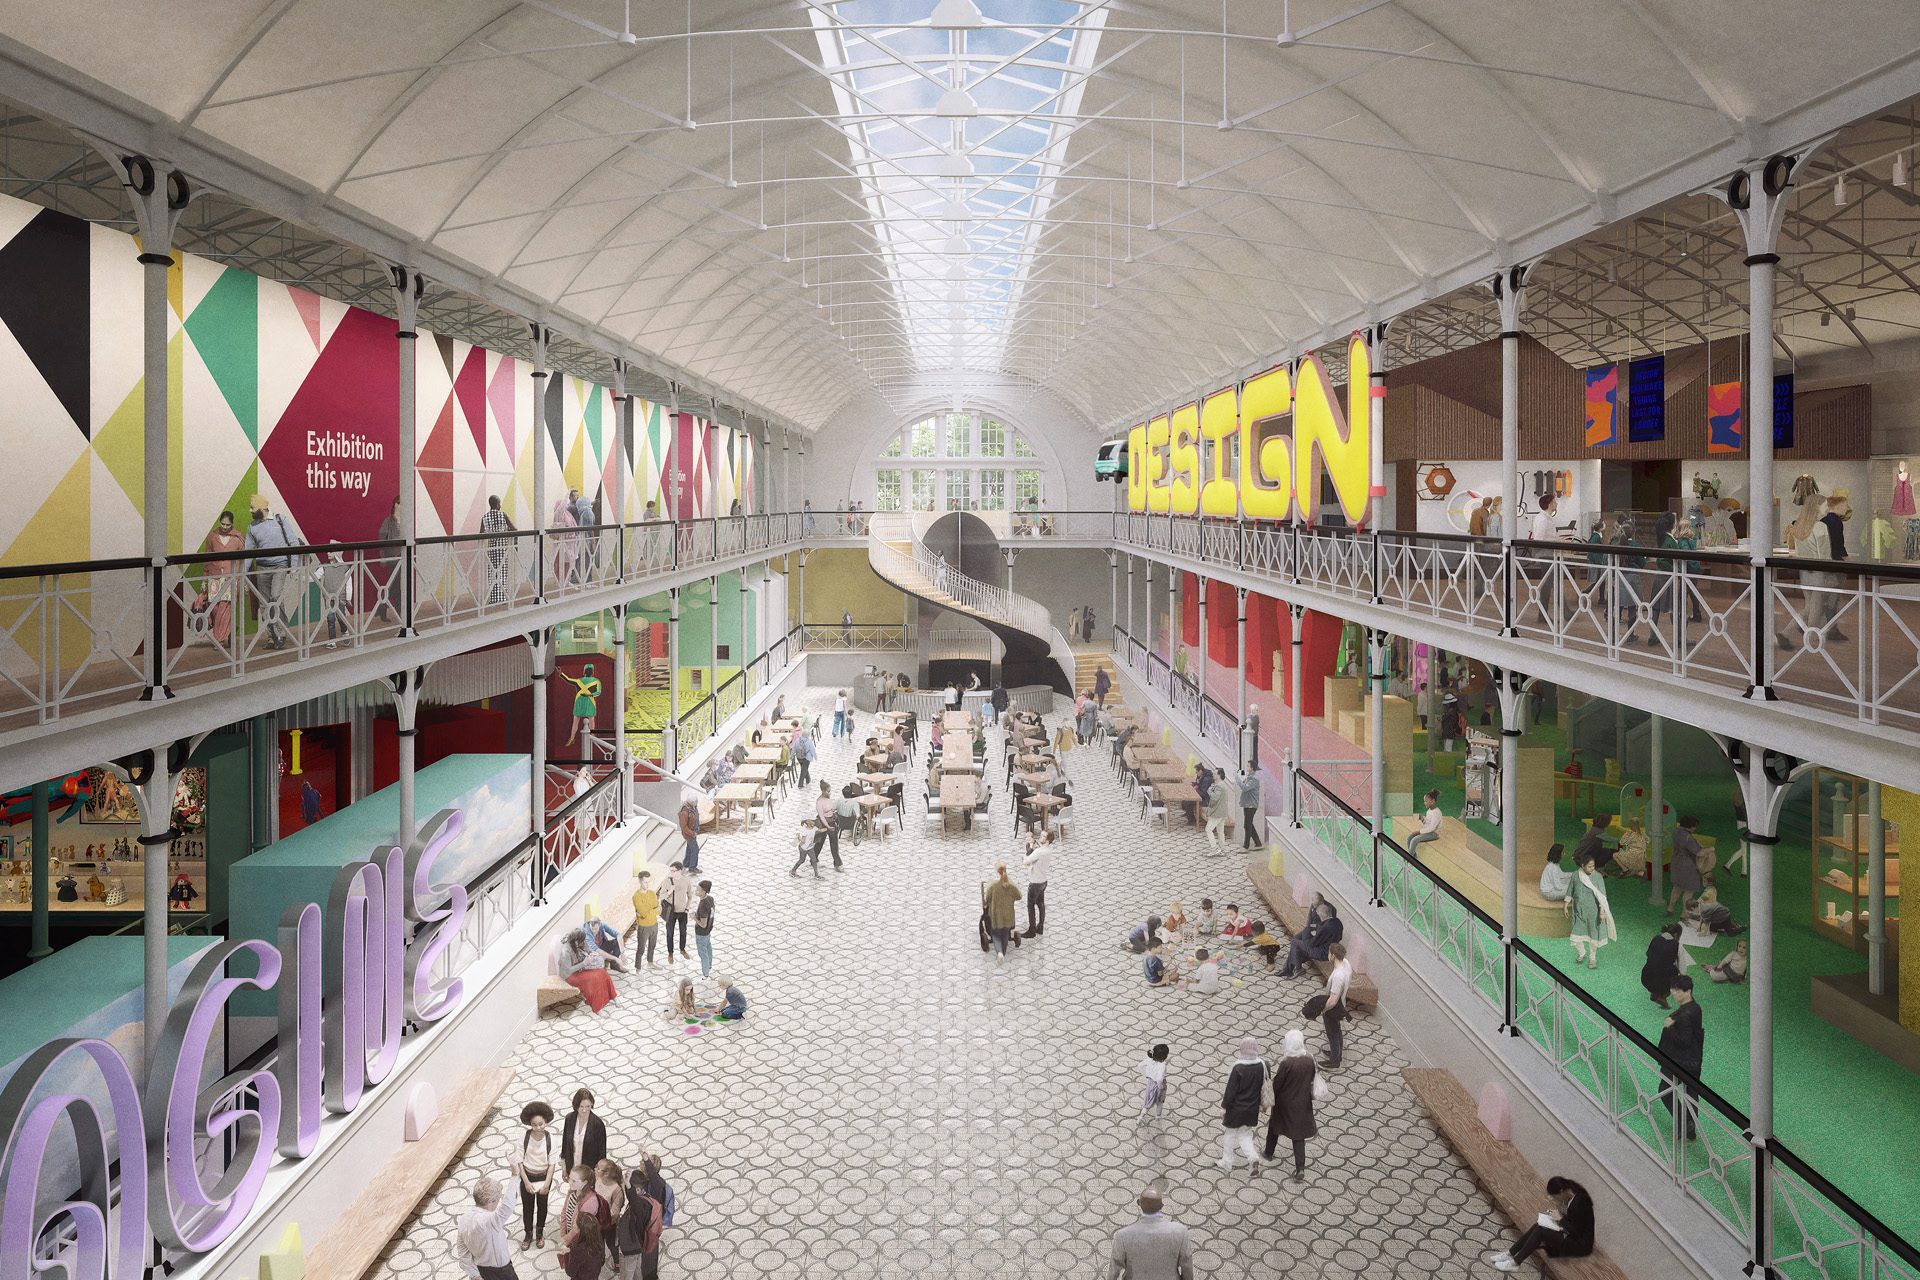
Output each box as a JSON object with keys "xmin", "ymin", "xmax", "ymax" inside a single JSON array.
[{"xmin": 0, "ymin": 0, "xmax": 1920, "ymax": 428}]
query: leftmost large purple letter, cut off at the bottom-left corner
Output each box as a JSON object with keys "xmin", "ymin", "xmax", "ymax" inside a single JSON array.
[{"xmin": 0, "ymin": 1040, "xmax": 148, "ymax": 1280}]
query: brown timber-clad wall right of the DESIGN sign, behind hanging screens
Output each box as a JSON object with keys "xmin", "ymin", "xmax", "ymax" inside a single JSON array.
[{"xmin": 1386, "ymin": 338, "xmax": 1874, "ymax": 462}]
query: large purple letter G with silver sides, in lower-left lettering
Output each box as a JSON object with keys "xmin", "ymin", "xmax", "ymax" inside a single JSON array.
[{"xmin": 142, "ymin": 940, "xmax": 280, "ymax": 1253}]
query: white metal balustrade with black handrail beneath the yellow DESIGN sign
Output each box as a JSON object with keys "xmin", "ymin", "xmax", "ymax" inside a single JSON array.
[{"xmin": 1112, "ymin": 512, "xmax": 1920, "ymax": 731}]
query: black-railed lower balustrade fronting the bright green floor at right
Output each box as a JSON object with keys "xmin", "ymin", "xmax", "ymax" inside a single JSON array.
[{"xmin": 1290, "ymin": 764, "xmax": 1920, "ymax": 1280}]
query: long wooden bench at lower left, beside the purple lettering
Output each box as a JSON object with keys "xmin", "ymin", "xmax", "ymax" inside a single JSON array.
[{"xmin": 305, "ymin": 1067, "xmax": 513, "ymax": 1280}]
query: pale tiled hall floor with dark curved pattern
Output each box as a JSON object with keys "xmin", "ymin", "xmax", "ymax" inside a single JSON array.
[{"xmin": 372, "ymin": 689, "xmax": 1511, "ymax": 1280}]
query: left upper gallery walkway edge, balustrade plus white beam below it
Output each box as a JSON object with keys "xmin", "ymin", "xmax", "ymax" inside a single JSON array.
[{"xmin": 0, "ymin": 512, "xmax": 803, "ymax": 789}]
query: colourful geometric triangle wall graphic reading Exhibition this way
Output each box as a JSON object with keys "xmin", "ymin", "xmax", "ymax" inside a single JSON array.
[{"xmin": 0, "ymin": 196, "xmax": 755, "ymax": 564}]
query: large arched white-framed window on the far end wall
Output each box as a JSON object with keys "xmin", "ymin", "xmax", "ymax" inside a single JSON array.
[{"xmin": 874, "ymin": 411, "xmax": 1050, "ymax": 510}]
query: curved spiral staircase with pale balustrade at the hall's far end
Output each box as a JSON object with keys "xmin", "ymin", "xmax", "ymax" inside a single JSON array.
[{"xmin": 866, "ymin": 510, "xmax": 1075, "ymax": 695}]
